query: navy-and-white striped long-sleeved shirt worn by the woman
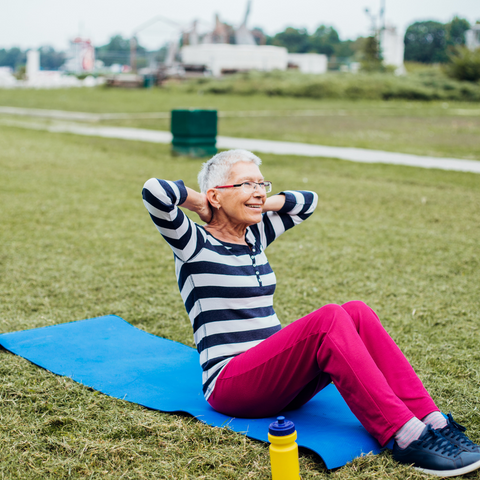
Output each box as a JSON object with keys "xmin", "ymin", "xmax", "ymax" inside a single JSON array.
[{"xmin": 143, "ymin": 178, "xmax": 317, "ymax": 399}]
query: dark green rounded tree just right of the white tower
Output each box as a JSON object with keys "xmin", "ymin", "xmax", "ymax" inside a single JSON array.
[{"xmin": 405, "ymin": 20, "xmax": 448, "ymax": 63}]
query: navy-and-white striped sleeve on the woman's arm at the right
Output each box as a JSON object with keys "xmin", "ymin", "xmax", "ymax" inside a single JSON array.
[{"xmin": 258, "ymin": 190, "xmax": 318, "ymax": 248}]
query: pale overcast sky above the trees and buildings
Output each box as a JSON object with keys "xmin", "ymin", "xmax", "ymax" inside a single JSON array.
[{"xmin": 0, "ymin": 0, "xmax": 480, "ymax": 50}]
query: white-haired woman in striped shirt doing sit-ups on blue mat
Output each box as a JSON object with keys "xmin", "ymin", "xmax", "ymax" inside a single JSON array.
[{"xmin": 143, "ymin": 150, "xmax": 480, "ymax": 476}]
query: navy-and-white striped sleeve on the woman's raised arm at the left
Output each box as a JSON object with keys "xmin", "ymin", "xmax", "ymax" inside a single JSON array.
[{"xmin": 142, "ymin": 178, "xmax": 204, "ymax": 261}]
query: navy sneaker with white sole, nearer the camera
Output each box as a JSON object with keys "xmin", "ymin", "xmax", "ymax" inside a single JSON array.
[{"xmin": 392, "ymin": 425, "xmax": 480, "ymax": 477}]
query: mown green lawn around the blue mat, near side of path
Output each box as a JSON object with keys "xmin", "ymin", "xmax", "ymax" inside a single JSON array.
[{"xmin": 0, "ymin": 122, "xmax": 480, "ymax": 480}]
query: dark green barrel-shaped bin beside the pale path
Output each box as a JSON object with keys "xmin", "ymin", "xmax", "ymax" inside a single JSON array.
[{"xmin": 171, "ymin": 110, "xmax": 217, "ymax": 157}]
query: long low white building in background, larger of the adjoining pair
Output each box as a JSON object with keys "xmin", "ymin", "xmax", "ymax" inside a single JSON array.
[{"xmin": 180, "ymin": 43, "xmax": 288, "ymax": 76}]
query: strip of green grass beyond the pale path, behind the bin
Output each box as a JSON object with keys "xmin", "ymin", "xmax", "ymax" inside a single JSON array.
[{"xmin": 0, "ymin": 88, "xmax": 480, "ymax": 160}]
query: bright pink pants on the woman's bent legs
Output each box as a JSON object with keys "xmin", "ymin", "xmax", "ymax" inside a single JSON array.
[{"xmin": 208, "ymin": 301, "xmax": 438, "ymax": 445}]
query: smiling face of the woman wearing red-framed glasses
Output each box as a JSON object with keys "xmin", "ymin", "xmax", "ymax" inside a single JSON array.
[{"xmin": 217, "ymin": 162, "xmax": 267, "ymax": 226}]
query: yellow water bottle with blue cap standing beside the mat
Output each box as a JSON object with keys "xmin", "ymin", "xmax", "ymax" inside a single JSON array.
[{"xmin": 268, "ymin": 417, "xmax": 300, "ymax": 480}]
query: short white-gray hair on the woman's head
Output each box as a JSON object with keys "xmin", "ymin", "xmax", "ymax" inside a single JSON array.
[{"xmin": 198, "ymin": 150, "xmax": 262, "ymax": 193}]
